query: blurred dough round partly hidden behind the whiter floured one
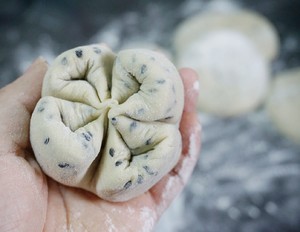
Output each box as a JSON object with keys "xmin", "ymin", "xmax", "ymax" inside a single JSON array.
[{"xmin": 174, "ymin": 10, "xmax": 279, "ymax": 60}]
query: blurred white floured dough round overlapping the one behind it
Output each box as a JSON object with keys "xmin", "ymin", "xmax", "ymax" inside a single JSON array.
[{"xmin": 178, "ymin": 30, "xmax": 269, "ymax": 117}]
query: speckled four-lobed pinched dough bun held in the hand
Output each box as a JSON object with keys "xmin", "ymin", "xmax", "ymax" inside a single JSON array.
[{"xmin": 30, "ymin": 45, "xmax": 183, "ymax": 201}]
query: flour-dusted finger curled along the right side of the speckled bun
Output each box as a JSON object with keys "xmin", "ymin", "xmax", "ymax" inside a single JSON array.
[{"xmin": 150, "ymin": 69, "xmax": 201, "ymax": 215}]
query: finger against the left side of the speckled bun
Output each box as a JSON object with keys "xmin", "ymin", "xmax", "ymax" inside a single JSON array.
[{"xmin": 0, "ymin": 59, "xmax": 47, "ymax": 155}]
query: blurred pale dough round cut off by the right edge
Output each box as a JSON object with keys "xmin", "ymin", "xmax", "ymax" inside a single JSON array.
[{"xmin": 267, "ymin": 68, "xmax": 300, "ymax": 144}]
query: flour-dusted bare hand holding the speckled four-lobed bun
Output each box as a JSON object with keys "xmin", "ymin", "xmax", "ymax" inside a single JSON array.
[{"xmin": 0, "ymin": 59, "xmax": 200, "ymax": 231}]
